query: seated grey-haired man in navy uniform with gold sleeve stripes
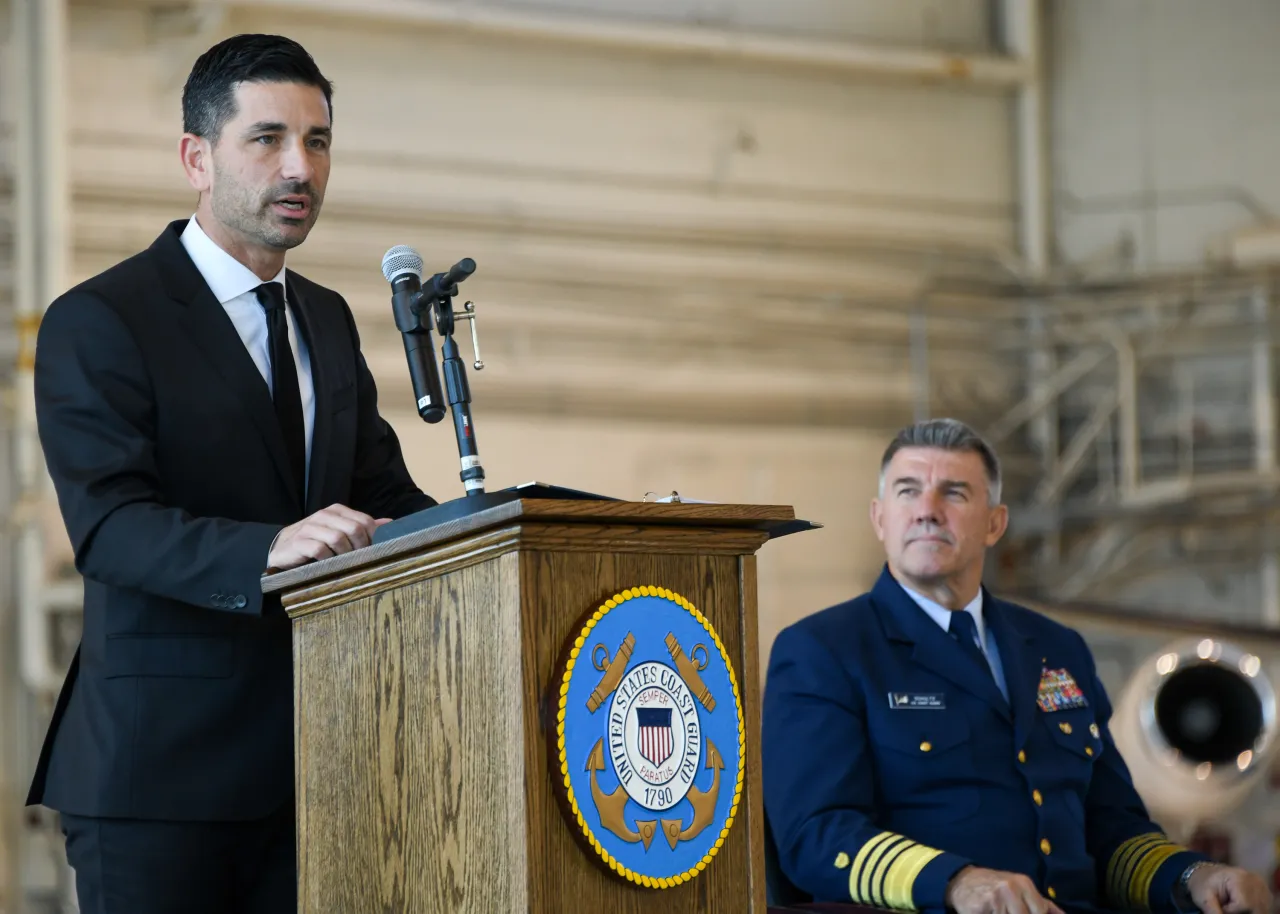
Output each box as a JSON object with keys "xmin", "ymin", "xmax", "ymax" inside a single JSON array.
[{"xmin": 763, "ymin": 420, "xmax": 1271, "ymax": 914}]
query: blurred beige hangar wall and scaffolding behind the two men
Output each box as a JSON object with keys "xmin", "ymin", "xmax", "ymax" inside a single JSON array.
[{"xmin": 0, "ymin": 0, "xmax": 1280, "ymax": 914}]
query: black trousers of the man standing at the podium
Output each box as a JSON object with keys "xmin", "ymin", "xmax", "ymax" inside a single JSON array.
[{"xmin": 61, "ymin": 801, "xmax": 297, "ymax": 914}]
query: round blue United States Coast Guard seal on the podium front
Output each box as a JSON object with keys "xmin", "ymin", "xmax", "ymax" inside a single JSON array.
[{"xmin": 553, "ymin": 586, "xmax": 746, "ymax": 888}]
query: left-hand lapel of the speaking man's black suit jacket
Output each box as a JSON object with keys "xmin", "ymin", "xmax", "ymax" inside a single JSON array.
[{"xmin": 151, "ymin": 219, "xmax": 302, "ymax": 509}]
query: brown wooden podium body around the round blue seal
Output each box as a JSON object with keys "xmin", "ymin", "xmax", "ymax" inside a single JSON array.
[{"xmin": 262, "ymin": 499, "xmax": 795, "ymax": 914}]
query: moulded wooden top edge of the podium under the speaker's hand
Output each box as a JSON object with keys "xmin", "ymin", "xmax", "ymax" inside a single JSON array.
[{"xmin": 261, "ymin": 498, "xmax": 812, "ymax": 594}]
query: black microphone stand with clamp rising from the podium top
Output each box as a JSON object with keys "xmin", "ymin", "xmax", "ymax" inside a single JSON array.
[{"xmin": 417, "ymin": 257, "xmax": 484, "ymax": 495}]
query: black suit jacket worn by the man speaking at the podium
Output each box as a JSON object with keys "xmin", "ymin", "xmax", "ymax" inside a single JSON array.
[{"xmin": 27, "ymin": 220, "xmax": 435, "ymax": 821}]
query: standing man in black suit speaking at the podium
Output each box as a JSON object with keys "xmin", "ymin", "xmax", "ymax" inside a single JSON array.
[{"xmin": 28, "ymin": 36, "xmax": 434, "ymax": 914}]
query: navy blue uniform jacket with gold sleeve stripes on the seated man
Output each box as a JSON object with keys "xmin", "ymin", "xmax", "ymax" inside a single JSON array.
[{"xmin": 763, "ymin": 568, "xmax": 1202, "ymax": 911}]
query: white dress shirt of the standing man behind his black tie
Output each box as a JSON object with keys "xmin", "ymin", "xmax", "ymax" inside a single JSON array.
[{"xmin": 182, "ymin": 216, "xmax": 316, "ymax": 489}]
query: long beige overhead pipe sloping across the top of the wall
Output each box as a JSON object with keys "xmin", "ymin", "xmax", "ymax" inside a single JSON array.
[{"xmin": 241, "ymin": 0, "xmax": 1030, "ymax": 90}]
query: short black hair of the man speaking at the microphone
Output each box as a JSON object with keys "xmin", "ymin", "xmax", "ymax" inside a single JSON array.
[{"xmin": 182, "ymin": 35, "xmax": 333, "ymax": 143}]
